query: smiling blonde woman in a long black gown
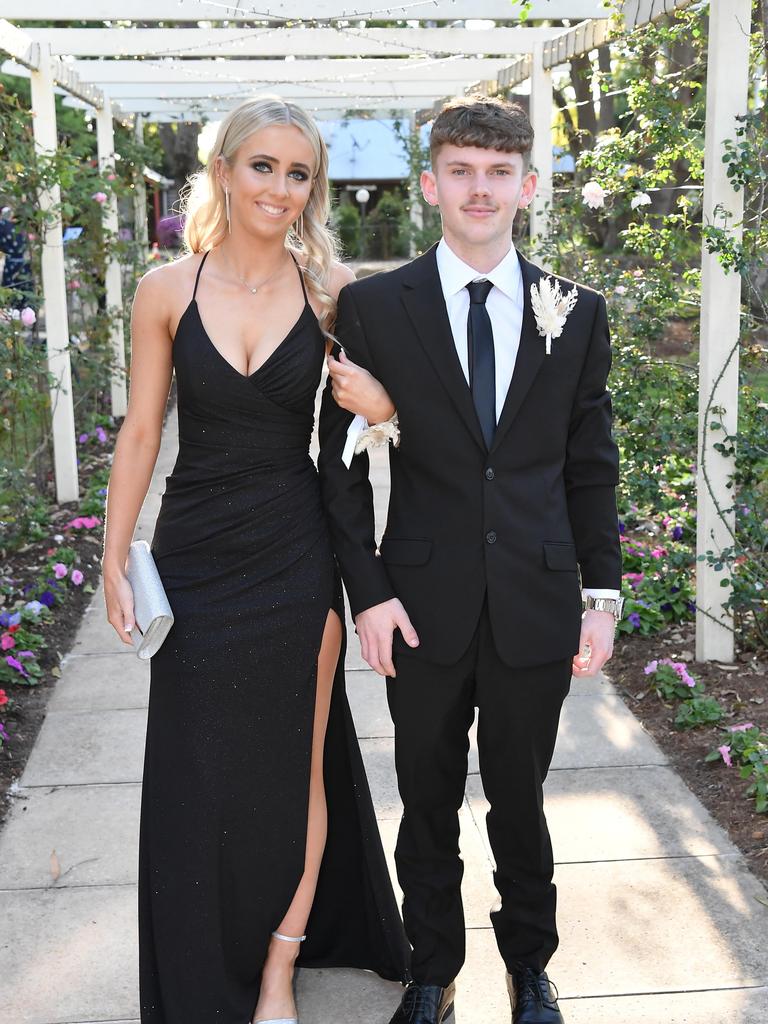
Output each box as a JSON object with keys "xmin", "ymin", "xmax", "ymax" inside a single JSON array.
[{"xmin": 103, "ymin": 97, "xmax": 415, "ymax": 1024}]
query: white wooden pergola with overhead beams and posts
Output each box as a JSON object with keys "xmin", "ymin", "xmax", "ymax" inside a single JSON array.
[{"xmin": 0, "ymin": 0, "xmax": 751, "ymax": 662}]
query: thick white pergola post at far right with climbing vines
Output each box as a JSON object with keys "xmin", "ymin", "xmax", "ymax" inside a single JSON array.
[{"xmin": 696, "ymin": 0, "xmax": 752, "ymax": 662}]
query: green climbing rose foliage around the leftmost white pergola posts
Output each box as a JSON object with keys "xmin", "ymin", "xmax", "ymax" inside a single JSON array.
[{"xmin": 0, "ymin": 80, "xmax": 152, "ymax": 550}]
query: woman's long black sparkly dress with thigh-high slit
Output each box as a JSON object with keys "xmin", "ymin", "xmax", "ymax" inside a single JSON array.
[{"xmin": 139, "ymin": 249, "xmax": 408, "ymax": 1024}]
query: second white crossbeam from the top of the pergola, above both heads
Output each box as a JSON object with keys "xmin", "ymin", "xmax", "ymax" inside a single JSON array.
[{"xmin": 26, "ymin": 27, "xmax": 562, "ymax": 58}]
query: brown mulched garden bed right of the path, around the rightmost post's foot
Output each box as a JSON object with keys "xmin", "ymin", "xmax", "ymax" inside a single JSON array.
[{"xmin": 606, "ymin": 623, "xmax": 768, "ymax": 885}]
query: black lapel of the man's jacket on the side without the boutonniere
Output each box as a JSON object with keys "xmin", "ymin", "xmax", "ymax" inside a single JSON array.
[{"xmin": 402, "ymin": 246, "xmax": 485, "ymax": 452}]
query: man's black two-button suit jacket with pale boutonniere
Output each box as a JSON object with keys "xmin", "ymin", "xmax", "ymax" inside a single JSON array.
[{"xmin": 318, "ymin": 248, "xmax": 621, "ymax": 667}]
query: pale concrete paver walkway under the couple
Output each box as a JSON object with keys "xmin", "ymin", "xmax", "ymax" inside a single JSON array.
[{"xmin": 0, "ymin": 407, "xmax": 768, "ymax": 1024}]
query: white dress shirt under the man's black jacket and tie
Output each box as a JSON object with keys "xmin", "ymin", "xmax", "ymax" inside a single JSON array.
[{"xmin": 344, "ymin": 239, "xmax": 618, "ymax": 598}]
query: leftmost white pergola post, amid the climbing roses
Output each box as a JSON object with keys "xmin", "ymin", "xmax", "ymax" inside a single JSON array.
[{"xmin": 31, "ymin": 43, "xmax": 80, "ymax": 504}]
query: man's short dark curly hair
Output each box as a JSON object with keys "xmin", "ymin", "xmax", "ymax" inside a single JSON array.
[{"xmin": 429, "ymin": 96, "xmax": 534, "ymax": 171}]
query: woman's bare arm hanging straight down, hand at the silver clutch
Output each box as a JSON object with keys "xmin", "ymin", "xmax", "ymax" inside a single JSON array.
[{"xmin": 101, "ymin": 268, "xmax": 172, "ymax": 644}]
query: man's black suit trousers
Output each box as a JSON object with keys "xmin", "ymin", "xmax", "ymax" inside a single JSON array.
[{"xmin": 387, "ymin": 605, "xmax": 570, "ymax": 986}]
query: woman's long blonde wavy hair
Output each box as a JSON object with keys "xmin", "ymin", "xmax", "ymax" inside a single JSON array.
[{"xmin": 181, "ymin": 96, "xmax": 338, "ymax": 339}]
